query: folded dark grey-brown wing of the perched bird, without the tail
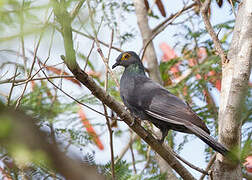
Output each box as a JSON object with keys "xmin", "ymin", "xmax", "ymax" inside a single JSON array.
[{"xmin": 135, "ymin": 78, "xmax": 209, "ymax": 133}]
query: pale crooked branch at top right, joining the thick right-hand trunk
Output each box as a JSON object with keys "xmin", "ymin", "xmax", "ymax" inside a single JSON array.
[{"xmin": 198, "ymin": 0, "xmax": 229, "ymax": 63}]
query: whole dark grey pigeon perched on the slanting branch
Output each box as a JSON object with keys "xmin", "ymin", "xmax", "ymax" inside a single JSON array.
[{"xmin": 112, "ymin": 51, "xmax": 229, "ymax": 156}]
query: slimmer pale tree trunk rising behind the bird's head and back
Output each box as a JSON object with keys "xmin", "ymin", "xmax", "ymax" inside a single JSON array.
[{"xmin": 134, "ymin": 0, "xmax": 178, "ymax": 180}]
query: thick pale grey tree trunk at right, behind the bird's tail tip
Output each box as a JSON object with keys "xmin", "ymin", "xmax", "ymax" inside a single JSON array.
[{"xmin": 213, "ymin": 0, "xmax": 252, "ymax": 180}]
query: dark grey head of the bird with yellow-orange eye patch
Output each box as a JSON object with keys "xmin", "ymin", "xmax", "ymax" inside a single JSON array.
[{"xmin": 112, "ymin": 51, "xmax": 141, "ymax": 69}]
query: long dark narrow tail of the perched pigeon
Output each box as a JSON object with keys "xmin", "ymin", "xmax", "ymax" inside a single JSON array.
[{"xmin": 187, "ymin": 124, "xmax": 230, "ymax": 156}]
